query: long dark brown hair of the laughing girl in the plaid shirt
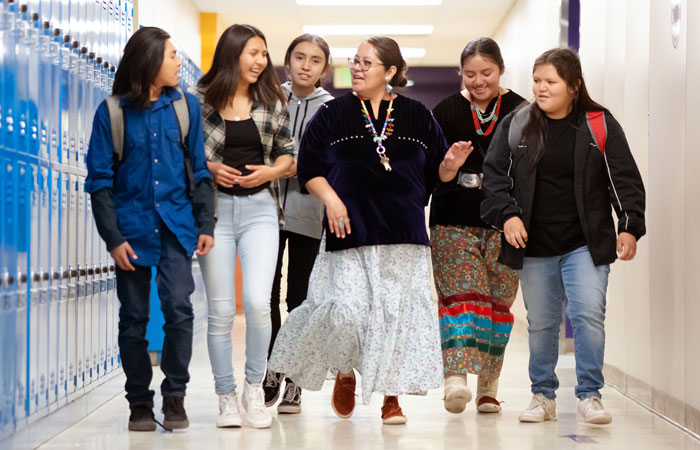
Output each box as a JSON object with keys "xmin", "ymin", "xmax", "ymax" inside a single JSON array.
[{"xmin": 197, "ymin": 24, "xmax": 287, "ymax": 110}]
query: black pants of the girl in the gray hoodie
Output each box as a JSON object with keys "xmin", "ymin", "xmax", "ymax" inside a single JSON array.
[{"xmin": 267, "ymin": 231, "xmax": 321, "ymax": 358}]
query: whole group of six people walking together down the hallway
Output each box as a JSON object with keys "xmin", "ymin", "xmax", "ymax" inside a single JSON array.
[{"xmin": 86, "ymin": 21, "xmax": 645, "ymax": 431}]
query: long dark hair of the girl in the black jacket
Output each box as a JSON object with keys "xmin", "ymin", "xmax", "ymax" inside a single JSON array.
[{"xmin": 523, "ymin": 48, "xmax": 607, "ymax": 167}]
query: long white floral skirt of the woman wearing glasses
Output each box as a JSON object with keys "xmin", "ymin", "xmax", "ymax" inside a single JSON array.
[{"xmin": 269, "ymin": 237, "xmax": 443, "ymax": 404}]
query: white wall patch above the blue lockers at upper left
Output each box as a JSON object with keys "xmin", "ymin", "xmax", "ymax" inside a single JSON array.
[{"xmin": 134, "ymin": 0, "xmax": 202, "ymax": 67}]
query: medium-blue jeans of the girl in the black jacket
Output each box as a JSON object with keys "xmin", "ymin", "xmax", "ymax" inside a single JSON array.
[{"xmin": 518, "ymin": 246, "xmax": 610, "ymax": 400}]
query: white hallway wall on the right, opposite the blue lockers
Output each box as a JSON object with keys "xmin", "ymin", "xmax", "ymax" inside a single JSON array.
[{"xmin": 494, "ymin": 0, "xmax": 700, "ymax": 432}]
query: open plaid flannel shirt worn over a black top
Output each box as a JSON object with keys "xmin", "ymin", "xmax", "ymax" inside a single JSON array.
[{"xmin": 189, "ymin": 86, "xmax": 296, "ymax": 226}]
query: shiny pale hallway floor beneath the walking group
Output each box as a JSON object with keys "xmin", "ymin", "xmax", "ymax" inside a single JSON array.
[{"xmin": 32, "ymin": 317, "xmax": 700, "ymax": 450}]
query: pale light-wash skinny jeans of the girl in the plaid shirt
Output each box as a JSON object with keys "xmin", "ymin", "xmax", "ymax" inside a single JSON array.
[{"xmin": 200, "ymin": 189, "xmax": 279, "ymax": 394}]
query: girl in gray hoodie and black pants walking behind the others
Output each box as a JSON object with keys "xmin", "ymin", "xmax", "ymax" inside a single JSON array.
[{"xmin": 264, "ymin": 34, "xmax": 333, "ymax": 414}]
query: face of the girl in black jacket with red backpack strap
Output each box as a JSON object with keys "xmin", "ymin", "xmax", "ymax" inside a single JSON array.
[{"xmin": 532, "ymin": 64, "xmax": 575, "ymax": 119}]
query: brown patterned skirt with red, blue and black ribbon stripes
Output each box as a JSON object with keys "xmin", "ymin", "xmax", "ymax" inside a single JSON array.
[{"xmin": 430, "ymin": 225, "xmax": 518, "ymax": 380}]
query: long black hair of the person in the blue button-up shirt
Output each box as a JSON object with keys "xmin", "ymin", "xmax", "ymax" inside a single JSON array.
[{"xmin": 112, "ymin": 27, "xmax": 170, "ymax": 109}]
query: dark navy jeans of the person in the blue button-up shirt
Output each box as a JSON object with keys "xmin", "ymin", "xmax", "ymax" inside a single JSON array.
[{"xmin": 116, "ymin": 227, "xmax": 194, "ymax": 407}]
